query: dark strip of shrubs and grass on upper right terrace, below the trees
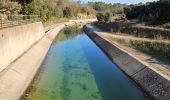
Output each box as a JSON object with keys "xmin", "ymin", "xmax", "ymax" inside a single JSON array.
[{"xmin": 94, "ymin": 22, "xmax": 170, "ymax": 40}]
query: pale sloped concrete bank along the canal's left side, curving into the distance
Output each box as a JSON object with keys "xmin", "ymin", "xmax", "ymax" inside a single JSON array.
[{"xmin": 0, "ymin": 20, "xmax": 93, "ymax": 100}]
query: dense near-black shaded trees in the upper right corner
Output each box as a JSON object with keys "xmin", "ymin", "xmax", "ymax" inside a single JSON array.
[{"xmin": 124, "ymin": 0, "xmax": 170, "ymax": 24}]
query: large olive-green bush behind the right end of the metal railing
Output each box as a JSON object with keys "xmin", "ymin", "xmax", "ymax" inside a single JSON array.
[{"xmin": 22, "ymin": 0, "xmax": 63, "ymax": 22}]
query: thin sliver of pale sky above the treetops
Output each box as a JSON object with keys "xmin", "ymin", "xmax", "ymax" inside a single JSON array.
[{"xmin": 74, "ymin": 0, "xmax": 156, "ymax": 4}]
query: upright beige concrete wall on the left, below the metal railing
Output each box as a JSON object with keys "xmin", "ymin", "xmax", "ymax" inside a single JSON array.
[{"xmin": 0, "ymin": 22, "xmax": 44, "ymax": 72}]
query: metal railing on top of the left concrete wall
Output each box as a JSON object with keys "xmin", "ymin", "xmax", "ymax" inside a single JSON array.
[{"xmin": 0, "ymin": 15, "xmax": 40, "ymax": 29}]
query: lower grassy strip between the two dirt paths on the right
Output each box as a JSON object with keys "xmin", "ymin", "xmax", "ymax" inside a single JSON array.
[{"xmin": 103, "ymin": 33, "xmax": 170, "ymax": 64}]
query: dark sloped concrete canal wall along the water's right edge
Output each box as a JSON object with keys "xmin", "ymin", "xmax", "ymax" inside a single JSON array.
[{"xmin": 84, "ymin": 26, "xmax": 170, "ymax": 100}]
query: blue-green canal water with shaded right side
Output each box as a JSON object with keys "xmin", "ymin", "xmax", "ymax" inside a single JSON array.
[{"xmin": 26, "ymin": 27, "xmax": 146, "ymax": 100}]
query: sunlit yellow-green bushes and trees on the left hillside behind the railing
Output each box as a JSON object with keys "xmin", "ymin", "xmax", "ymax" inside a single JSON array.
[{"xmin": 0, "ymin": 0, "xmax": 95, "ymax": 21}]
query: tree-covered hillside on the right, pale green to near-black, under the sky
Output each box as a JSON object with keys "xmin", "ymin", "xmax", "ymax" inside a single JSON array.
[{"xmin": 93, "ymin": 0, "xmax": 170, "ymax": 25}]
